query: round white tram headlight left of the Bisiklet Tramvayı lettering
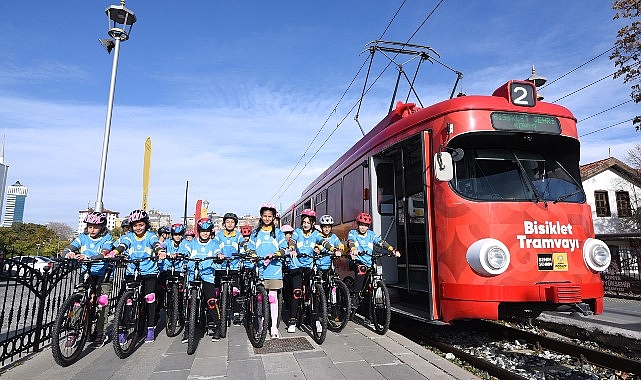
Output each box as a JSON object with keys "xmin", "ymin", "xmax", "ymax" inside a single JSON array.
[{"xmin": 465, "ymin": 238, "xmax": 510, "ymax": 276}]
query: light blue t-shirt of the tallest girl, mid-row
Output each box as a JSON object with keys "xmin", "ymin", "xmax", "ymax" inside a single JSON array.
[{"xmin": 247, "ymin": 228, "xmax": 287, "ymax": 280}]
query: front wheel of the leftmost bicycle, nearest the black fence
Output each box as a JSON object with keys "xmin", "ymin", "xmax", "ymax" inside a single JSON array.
[{"xmin": 51, "ymin": 294, "xmax": 89, "ymax": 367}]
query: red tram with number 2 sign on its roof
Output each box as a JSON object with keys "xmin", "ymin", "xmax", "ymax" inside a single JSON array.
[{"xmin": 282, "ymin": 80, "xmax": 610, "ymax": 322}]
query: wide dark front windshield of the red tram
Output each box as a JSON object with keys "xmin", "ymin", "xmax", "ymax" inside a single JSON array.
[{"xmin": 450, "ymin": 148, "xmax": 585, "ymax": 203}]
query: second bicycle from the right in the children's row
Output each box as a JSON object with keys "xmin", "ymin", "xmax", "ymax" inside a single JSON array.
[{"xmin": 323, "ymin": 253, "xmax": 352, "ymax": 332}]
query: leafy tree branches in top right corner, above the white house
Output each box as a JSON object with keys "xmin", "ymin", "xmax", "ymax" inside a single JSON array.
[{"xmin": 610, "ymin": 0, "xmax": 641, "ymax": 131}]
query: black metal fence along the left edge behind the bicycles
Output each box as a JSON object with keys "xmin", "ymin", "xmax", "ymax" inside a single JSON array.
[{"xmin": 0, "ymin": 256, "xmax": 124, "ymax": 368}]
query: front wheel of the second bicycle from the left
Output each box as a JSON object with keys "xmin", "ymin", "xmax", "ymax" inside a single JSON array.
[{"xmin": 111, "ymin": 290, "xmax": 140, "ymax": 359}]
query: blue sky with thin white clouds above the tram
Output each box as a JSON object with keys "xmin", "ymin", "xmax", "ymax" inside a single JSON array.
[{"xmin": 0, "ymin": 0, "xmax": 639, "ymax": 226}]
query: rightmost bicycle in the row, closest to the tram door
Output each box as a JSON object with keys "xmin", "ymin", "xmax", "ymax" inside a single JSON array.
[{"xmin": 350, "ymin": 247, "xmax": 394, "ymax": 335}]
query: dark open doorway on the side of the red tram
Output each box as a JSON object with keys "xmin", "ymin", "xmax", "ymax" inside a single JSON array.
[{"xmin": 371, "ymin": 136, "xmax": 430, "ymax": 305}]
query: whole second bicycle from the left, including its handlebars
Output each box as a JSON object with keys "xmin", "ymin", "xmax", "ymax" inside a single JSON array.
[{"xmin": 111, "ymin": 257, "xmax": 157, "ymax": 359}]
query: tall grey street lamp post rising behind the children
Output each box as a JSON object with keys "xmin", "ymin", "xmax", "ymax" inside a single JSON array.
[{"xmin": 94, "ymin": 0, "xmax": 136, "ymax": 212}]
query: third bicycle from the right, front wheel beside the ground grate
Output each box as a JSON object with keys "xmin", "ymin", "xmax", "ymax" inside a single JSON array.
[{"xmin": 296, "ymin": 253, "xmax": 327, "ymax": 344}]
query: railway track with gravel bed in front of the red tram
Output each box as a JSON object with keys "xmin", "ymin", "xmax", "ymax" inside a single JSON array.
[{"xmin": 391, "ymin": 315, "xmax": 641, "ymax": 380}]
